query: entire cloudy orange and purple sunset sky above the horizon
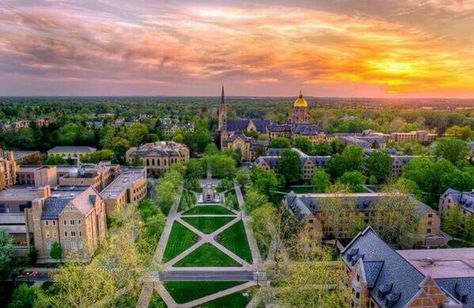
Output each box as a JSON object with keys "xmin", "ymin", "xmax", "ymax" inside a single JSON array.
[{"xmin": 0, "ymin": 0, "xmax": 474, "ymax": 98}]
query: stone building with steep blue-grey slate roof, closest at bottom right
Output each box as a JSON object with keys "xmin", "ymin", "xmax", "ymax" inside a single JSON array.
[{"xmin": 341, "ymin": 227, "xmax": 464, "ymax": 308}]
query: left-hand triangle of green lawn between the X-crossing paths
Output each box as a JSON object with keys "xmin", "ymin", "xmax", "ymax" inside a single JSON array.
[{"xmin": 163, "ymin": 221, "xmax": 199, "ymax": 262}]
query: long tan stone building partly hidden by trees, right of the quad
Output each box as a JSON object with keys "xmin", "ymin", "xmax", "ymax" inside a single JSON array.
[{"xmin": 283, "ymin": 192, "xmax": 447, "ymax": 246}]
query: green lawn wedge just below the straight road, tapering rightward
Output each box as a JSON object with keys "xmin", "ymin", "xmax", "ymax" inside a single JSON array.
[{"xmin": 164, "ymin": 281, "xmax": 245, "ymax": 304}]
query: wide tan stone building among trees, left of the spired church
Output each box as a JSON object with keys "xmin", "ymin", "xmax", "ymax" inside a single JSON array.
[{"xmin": 125, "ymin": 141, "xmax": 189, "ymax": 175}]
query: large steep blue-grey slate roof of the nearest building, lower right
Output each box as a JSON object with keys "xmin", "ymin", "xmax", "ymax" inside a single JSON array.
[{"xmin": 342, "ymin": 227, "xmax": 425, "ymax": 308}]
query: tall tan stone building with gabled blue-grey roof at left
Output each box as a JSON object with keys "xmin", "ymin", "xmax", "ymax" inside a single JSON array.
[{"xmin": 29, "ymin": 187, "xmax": 107, "ymax": 261}]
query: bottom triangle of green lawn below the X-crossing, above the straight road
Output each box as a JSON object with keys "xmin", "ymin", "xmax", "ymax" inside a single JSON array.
[{"xmin": 174, "ymin": 243, "xmax": 242, "ymax": 267}]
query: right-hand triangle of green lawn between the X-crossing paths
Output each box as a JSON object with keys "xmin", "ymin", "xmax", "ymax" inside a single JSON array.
[{"xmin": 216, "ymin": 220, "xmax": 252, "ymax": 263}]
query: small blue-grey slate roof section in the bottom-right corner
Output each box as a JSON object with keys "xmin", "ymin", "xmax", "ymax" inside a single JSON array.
[{"xmin": 435, "ymin": 277, "xmax": 474, "ymax": 308}]
